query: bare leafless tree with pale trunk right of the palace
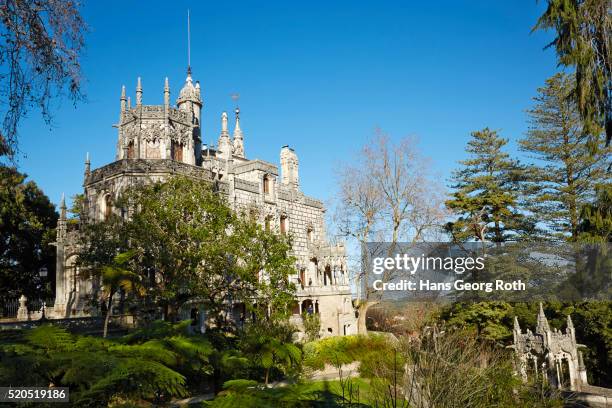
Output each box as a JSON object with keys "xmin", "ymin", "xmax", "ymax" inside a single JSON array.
[{"xmin": 334, "ymin": 131, "xmax": 446, "ymax": 333}]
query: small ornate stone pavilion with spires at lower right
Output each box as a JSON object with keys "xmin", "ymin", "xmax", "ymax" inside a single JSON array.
[{"xmin": 512, "ymin": 303, "xmax": 588, "ymax": 391}]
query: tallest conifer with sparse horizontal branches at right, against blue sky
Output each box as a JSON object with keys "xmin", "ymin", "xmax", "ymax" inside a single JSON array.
[{"xmin": 519, "ymin": 73, "xmax": 609, "ymax": 240}]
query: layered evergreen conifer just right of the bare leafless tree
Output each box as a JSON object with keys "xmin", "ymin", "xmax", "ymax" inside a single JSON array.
[{"xmin": 446, "ymin": 128, "xmax": 528, "ymax": 242}]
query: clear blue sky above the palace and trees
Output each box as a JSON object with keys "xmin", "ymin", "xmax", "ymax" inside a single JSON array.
[{"xmin": 19, "ymin": 0, "xmax": 557, "ymax": 214}]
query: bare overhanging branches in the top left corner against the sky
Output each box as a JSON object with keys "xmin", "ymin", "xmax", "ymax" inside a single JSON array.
[{"xmin": 0, "ymin": 0, "xmax": 85, "ymax": 159}]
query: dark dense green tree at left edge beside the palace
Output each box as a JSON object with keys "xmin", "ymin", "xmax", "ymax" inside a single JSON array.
[{"xmin": 0, "ymin": 166, "xmax": 58, "ymax": 303}]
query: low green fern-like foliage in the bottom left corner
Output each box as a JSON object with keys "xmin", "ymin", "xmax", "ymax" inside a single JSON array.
[{"xmin": 0, "ymin": 324, "xmax": 220, "ymax": 407}]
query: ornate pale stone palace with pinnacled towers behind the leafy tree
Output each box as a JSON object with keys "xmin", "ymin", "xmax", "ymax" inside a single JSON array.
[{"xmin": 54, "ymin": 70, "xmax": 357, "ymax": 336}]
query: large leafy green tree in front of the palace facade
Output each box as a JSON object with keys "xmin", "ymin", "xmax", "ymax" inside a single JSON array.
[{"xmin": 79, "ymin": 177, "xmax": 294, "ymax": 327}]
